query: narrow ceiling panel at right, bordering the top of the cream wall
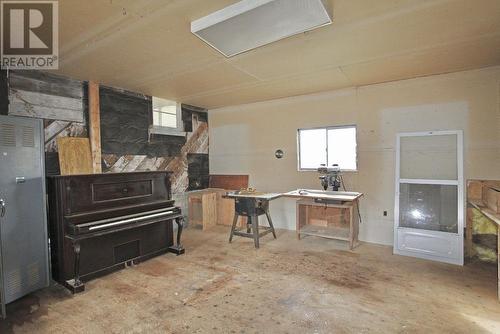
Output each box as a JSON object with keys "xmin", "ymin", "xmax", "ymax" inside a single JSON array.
[{"xmin": 342, "ymin": 35, "xmax": 500, "ymax": 86}]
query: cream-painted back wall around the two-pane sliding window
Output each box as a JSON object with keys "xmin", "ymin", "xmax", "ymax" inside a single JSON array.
[{"xmin": 209, "ymin": 67, "xmax": 500, "ymax": 244}]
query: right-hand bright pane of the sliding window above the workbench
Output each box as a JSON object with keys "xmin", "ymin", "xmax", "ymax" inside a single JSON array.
[{"xmin": 328, "ymin": 127, "xmax": 356, "ymax": 170}]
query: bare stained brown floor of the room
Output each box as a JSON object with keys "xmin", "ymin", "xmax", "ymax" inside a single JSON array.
[{"xmin": 0, "ymin": 227, "xmax": 500, "ymax": 333}]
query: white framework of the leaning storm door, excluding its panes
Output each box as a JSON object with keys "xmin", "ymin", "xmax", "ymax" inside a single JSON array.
[{"xmin": 393, "ymin": 130, "xmax": 465, "ymax": 265}]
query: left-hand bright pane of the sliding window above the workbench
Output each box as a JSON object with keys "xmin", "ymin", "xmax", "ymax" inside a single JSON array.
[{"xmin": 299, "ymin": 129, "xmax": 326, "ymax": 169}]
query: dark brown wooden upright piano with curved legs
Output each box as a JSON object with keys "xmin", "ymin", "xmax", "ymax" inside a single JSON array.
[{"xmin": 47, "ymin": 172, "xmax": 184, "ymax": 293}]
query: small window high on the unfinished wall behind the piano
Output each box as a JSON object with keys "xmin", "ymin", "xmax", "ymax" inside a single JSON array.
[{"xmin": 151, "ymin": 96, "xmax": 184, "ymax": 135}]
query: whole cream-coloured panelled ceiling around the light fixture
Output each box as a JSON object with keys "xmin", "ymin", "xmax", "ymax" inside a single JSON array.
[{"xmin": 55, "ymin": 0, "xmax": 500, "ymax": 108}]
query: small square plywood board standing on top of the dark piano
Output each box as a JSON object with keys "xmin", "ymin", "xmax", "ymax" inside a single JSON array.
[{"xmin": 57, "ymin": 137, "xmax": 92, "ymax": 175}]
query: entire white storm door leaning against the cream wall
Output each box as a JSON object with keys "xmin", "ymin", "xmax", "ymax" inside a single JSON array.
[{"xmin": 394, "ymin": 131, "xmax": 464, "ymax": 265}]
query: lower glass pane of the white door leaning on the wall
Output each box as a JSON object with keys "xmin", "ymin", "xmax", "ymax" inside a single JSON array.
[{"xmin": 399, "ymin": 183, "xmax": 458, "ymax": 233}]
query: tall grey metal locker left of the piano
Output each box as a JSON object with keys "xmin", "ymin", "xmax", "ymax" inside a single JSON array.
[{"xmin": 0, "ymin": 116, "xmax": 49, "ymax": 317}]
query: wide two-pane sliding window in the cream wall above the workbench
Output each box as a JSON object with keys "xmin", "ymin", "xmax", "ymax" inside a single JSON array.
[{"xmin": 298, "ymin": 126, "xmax": 357, "ymax": 170}]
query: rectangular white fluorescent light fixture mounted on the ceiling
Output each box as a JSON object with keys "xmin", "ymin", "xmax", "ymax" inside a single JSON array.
[{"xmin": 191, "ymin": 0, "xmax": 332, "ymax": 57}]
